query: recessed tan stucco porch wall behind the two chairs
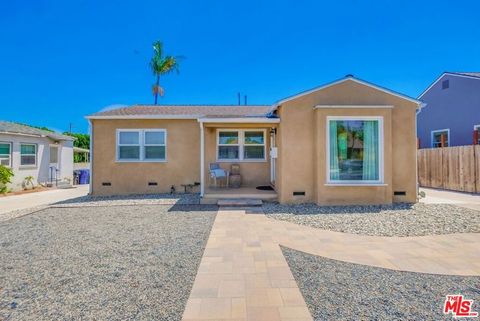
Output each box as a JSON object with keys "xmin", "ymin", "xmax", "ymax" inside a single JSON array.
[{"xmin": 205, "ymin": 124, "xmax": 276, "ymax": 187}]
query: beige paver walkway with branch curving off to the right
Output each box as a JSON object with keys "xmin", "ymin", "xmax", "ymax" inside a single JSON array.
[{"xmin": 183, "ymin": 209, "xmax": 480, "ymax": 321}]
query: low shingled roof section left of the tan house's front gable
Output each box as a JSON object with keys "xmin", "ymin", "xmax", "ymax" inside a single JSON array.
[{"xmin": 87, "ymin": 105, "xmax": 270, "ymax": 119}]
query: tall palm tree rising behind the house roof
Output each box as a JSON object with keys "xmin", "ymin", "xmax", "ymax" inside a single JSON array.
[{"xmin": 150, "ymin": 41, "xmax": 181, "ymax": 105}]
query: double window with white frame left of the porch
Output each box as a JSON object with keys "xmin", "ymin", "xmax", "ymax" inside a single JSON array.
[{"xmin": 117, "ymin": 129, "xmax": 167, "ymax": 162}]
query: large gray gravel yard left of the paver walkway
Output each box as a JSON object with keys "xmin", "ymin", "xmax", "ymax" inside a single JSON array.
[{"xmin": 0, "ymin": 205, "xmax": 217, "ymax": 320}]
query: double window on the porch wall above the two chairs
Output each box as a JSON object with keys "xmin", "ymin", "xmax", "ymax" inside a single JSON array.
[{"xmin": 217, "ymin": 129, "xmax": 266, "ymax": 161}]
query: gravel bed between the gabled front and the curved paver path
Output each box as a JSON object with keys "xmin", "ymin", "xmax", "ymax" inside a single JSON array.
[{"xmin": 263, "ymin": 203, "xmax": 480, "ymax": 236}]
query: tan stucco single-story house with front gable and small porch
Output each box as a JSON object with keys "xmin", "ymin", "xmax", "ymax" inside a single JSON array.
[{"xmin": 87, "ymin": 76, "xmax": 422, "ymax": 204}]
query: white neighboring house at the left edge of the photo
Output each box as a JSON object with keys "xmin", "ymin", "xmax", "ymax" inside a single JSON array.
[{"xmin": 0, "ymin": 121, "xmax": 73, "ymax": 191}]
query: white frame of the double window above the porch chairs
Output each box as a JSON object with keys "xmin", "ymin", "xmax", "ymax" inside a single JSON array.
[{"xmin": 215, "ymin": 128, "xmax": 267, "ymax": 163}]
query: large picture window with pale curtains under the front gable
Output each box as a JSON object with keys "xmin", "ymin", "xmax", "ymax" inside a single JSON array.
[{"xmin": 327, "ymin": 117, "xmax": 383, "ymax": 184}]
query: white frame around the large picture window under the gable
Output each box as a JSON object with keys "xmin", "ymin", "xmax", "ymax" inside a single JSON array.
[{"xmin": 325, "ymin": 116, "xmax": 385, "ymax": 186}]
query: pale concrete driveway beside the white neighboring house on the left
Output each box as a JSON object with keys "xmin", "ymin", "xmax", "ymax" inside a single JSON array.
[{"xmin": 0, "ymin": 185, "xmax": 88, "ymax": 215}]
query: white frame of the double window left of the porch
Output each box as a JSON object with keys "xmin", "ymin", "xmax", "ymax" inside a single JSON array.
[{"xmin": 115, "ymin": 128, "xmax": 167, "ymax": 163}]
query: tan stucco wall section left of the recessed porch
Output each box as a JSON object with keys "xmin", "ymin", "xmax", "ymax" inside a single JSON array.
[{"xmin": 92, "ymin": 119, "xmax": 200, "ymax": 195}]
